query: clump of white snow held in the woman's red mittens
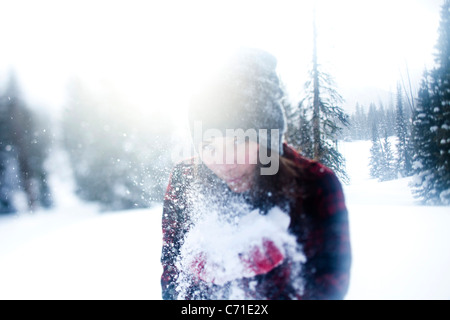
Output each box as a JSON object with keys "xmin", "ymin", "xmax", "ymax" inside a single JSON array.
[{"xmin": 178, "ymin": 207, "xmax": 297, "ymax": 285}]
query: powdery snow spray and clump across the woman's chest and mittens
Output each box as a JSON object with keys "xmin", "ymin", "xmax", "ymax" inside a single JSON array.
[{"xmin": 176, "ymin": 185, "xmax": 306, "ymax": 299}]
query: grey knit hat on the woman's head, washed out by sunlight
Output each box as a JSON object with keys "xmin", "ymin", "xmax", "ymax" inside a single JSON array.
[{"xmin": 189, "ymin": 48, "xmax": 286, "ymax": 154}]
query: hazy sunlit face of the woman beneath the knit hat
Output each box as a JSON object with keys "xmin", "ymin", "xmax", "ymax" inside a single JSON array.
[{"xmin": 200, "ymin": 137, "xmax": 259, "ymax": 192}]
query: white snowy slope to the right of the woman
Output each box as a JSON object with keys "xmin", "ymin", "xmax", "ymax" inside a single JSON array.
[{"xmin": 341, "ymin": 141, "xmax": 450, "ymax": 299}]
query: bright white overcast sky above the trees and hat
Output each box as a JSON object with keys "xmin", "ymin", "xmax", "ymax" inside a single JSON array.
[{"xmin": 0, "ymin": 0, "xmax": 443, "ymax": 117}]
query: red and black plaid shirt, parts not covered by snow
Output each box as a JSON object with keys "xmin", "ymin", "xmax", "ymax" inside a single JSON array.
[{"xmin": 161, "ymin": 144, "xmax": 351, "ymax": 299}]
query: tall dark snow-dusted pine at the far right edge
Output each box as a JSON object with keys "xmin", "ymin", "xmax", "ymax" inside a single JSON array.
[{"xmin": 413, "ymin": 0, "xmax": 450, "ymax": 205}]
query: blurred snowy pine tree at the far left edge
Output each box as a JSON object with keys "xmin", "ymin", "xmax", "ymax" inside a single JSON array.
[{"xmin": 0, "ymin": 72, "xmax": 52, "ymax": 211}]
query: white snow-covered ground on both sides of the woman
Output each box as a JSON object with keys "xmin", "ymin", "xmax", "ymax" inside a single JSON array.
[{"xmin": 0, "ymin": 142, "xmax": 450, "ymax": 299}]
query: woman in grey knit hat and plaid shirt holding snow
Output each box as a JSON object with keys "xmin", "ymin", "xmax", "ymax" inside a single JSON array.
[{"xmin": 161, "ymin": 49, "xmax": 351, "ymax": 299}]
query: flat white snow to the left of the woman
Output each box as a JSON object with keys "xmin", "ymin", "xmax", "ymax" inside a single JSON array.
[{"xmin": 0, "ymin": 206, "xmax": 162, "ymax": 299}]
